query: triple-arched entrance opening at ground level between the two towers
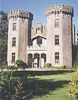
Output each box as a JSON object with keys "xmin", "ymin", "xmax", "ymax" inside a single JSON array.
[{"xmin": 28, "ymin": 53, "xmax": 46, "ymax": 68}]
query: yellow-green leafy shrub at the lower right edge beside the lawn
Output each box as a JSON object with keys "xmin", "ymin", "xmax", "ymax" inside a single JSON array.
[{"xmin": 68, "ymin": 71, "xmax": 78, "ymax": 100}]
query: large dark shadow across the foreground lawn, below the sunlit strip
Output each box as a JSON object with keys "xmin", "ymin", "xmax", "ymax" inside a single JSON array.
[{"xmin": 21, "ymin": 79, "xmax": 69, "ymax": 100}]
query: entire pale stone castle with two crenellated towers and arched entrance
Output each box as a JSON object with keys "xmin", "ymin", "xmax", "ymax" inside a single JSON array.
[{"xmin": 7, "ymin": 5, "xmax": 75, "ymax": 68}]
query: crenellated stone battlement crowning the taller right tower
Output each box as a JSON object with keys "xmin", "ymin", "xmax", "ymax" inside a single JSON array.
[{"xmin": 46, "ymin": 5, "xmax": 73, "ymax": 17}]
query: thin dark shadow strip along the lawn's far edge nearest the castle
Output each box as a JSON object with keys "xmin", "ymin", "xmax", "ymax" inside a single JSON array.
[{"xmin": 13, "ymin": 70, "xmax": 75, "ymax": 77}]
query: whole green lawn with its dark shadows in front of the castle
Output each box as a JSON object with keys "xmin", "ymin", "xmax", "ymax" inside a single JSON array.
[{"xmin": 0, "ymin": 69, "xmax": 76, "ymax": 100}]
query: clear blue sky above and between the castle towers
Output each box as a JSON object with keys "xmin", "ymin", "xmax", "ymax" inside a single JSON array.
[{"xmin": 0, "ymin": 0, "xmax": 78, "ymax": 32}]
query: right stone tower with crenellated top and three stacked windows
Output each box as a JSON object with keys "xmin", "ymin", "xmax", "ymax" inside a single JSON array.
[{"xmin": 46, "ymin": 5, "xmax": 73, "ymax": 67}]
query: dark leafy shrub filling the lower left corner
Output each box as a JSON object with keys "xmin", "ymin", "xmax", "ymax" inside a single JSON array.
[{"xmin": 0, "ymin": 67, "xmax": 27, "ymax": 100}]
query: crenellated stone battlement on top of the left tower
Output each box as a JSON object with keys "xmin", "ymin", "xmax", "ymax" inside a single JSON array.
[{"xmin": 8, "ymin": 10, "xmax": 33, "ymax": 20}]
